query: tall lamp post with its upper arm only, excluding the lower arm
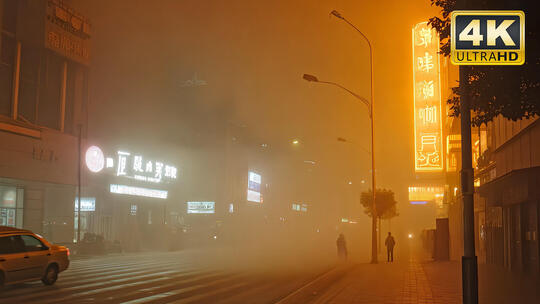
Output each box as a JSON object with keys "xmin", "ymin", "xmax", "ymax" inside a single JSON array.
[{"xmin": 330, "ymin": 10, "xmax": 377, "ymax": 264}]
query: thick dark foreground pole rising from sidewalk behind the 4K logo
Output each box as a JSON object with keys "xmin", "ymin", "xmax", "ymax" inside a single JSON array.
[{"xmin": 456, "ymin": 0, "xmax": 478, "ymax": 304}]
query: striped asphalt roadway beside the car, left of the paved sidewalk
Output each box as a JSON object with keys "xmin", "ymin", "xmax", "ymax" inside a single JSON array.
[{"xmin": 0, "ymin": 251, "xmax": 327, "ymax": 304}]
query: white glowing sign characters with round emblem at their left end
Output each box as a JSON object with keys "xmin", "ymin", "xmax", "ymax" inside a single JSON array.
[{"xmin": 86, "ymin": 146, "xmax": 178, "ymax": 183}]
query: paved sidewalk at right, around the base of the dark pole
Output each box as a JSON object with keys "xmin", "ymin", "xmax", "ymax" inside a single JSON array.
[{"xmin": 292, "ymin": 251, "xmax": 540, "ymax": 304}]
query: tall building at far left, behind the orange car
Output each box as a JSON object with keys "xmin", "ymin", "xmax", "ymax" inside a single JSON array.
[{"xmin": 0, "ymin": 0, "xmax": 90, "ymax": 242}]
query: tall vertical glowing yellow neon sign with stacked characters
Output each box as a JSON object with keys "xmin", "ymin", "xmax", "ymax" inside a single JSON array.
[{"xmin": 413, "ymin": 22, "xmax": 444, "ymax": 171}]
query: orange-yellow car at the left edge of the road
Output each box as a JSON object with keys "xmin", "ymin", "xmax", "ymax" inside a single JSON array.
[{"xmin": 0, "ymin": 226, "xmax": 69, "ymax": 286}]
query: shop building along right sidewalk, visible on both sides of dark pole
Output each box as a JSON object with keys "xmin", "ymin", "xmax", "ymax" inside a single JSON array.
[{"xmin": 445, "ymin": 63, "xmax": 540, "ymax": 274}]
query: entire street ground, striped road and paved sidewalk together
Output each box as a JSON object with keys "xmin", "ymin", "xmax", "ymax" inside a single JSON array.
[{"xmin": 0, "ymin": 246, "xmax": 540, "ymax": 304}]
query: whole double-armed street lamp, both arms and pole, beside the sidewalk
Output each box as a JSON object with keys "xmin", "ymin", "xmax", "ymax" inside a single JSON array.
[{"xmin": 303, "ymin": 10, "xmax": 377, "ymax": 264}]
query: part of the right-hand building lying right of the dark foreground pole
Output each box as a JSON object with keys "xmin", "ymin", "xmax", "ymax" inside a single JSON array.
[{"xmin": 476, "ymin": 117, "xmax": 540, "ymax": 274}]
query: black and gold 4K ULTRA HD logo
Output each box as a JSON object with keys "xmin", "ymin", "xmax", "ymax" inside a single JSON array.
[{"xmin": 450, "ymin": 11, "xmax": 525, "ymax": 65}]
